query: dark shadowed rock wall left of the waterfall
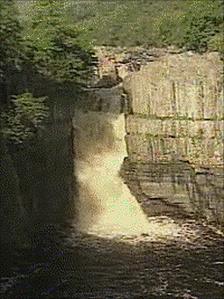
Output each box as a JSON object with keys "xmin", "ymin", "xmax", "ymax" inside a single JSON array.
[{"xmin": 0, "ymin": 74, "xmax": 76, "ymax": 246}]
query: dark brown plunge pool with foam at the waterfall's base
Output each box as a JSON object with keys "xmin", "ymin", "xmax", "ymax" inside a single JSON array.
[{"xmin": 0, "ymin": 217, "xmax": 224, "ymax": 299}]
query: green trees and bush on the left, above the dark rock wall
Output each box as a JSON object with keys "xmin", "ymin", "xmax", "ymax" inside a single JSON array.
[{"xmin": 0, "ymin": 0, "xmax": 94, "ymax": 143}]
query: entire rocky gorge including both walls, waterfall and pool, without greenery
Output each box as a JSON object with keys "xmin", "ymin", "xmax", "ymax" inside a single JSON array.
[{"xmin": 0, "ymin": 48, "xmax": 224, "ymax": 299}]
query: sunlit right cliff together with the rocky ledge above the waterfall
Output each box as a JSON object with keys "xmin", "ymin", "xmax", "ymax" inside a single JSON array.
[{"xmin": 85, "ymin": 47, "xmax": 224, "ymax": 228}]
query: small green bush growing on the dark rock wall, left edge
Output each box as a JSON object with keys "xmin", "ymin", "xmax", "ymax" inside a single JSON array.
[{"xmin": 0, "ymin": 92, "xmax": 48, "ymax": 144}]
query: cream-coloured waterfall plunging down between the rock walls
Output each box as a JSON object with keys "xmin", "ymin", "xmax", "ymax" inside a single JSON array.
[{"xmin": 73, "ymin": 111, "xmax": 149, "ymax": 235}]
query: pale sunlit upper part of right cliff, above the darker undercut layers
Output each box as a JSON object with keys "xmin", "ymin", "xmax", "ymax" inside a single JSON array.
[{"xmin": 124, "ymin": 54, "xmax": 224, "ymax": 167}]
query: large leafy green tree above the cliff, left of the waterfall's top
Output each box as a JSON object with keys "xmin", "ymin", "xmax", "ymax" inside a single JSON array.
[{"xmin": 26, "ymin": 0, "xmax": 96, "ymax": 83}]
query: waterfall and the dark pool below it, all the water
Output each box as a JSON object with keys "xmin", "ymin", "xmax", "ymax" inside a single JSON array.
[{"xmin": 0, "ymin": 113, "xmax": 224, "ymax": 299}]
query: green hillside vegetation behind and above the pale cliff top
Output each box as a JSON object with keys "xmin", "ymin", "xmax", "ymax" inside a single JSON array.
[{"xmin": 60, "ymin": 0, "xmax": 223, "ymax": 52}]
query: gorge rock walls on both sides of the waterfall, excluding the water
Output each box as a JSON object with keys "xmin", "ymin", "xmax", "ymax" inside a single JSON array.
[{"xmin": 1, "ymin": 47, "xmax": 224, "ymax": 246}]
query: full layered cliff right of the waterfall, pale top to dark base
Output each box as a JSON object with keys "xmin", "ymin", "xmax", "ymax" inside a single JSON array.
[{"xmin": 123, "ymin": 53, "xmax": 224, "ymax": 229}]
